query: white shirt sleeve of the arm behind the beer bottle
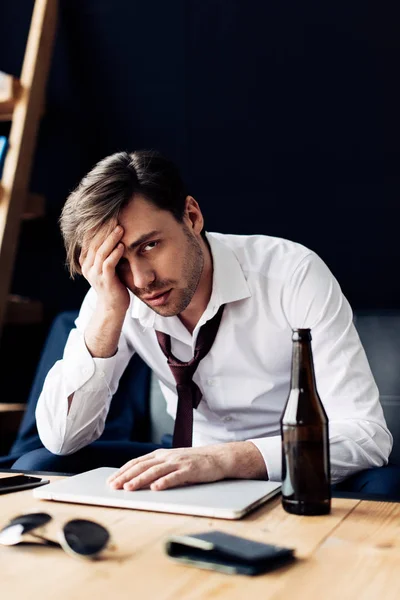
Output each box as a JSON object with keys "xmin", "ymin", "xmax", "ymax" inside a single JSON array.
[{"xmin": 251, "ymin": 253, "xmax": 393, "ymax": 483}]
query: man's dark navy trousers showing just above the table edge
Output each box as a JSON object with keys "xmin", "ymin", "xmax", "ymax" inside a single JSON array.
[{"xmin": 12, "ymin": 442, "xmax": 400, "ymax": 501}]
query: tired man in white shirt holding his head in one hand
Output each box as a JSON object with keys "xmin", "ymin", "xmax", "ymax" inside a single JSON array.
[{"xmin": 17, "ymin": 151, "xmax": 392, "ymax": 490}]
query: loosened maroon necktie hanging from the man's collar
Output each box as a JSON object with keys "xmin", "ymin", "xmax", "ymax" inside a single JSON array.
[{"xmin": 156, "ymin": 304, "xmax": 224, "ymax": 448}]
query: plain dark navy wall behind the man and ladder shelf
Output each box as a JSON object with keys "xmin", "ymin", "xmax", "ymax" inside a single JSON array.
[{"xmin": 0, "ymin": 0, "xmax": 400, "ymax": 398}]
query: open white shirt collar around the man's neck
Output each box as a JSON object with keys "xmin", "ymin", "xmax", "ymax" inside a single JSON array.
[{"xmin": 131, "ymin": 232, "xmax": 251, "ymax": 330}]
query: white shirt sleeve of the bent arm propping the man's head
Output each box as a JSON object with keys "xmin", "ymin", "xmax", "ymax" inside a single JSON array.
[{"xmin": 36, "ymin": 289, "xmax": 134, "ymax": 454}]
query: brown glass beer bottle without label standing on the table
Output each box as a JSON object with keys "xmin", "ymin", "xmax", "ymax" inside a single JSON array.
[{"xmin": 281, "ymin": 329, "xmax": 331, "ymax": 515}]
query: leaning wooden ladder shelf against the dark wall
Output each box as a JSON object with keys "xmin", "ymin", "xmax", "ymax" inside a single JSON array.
[{"xmin": 0, "ymin": 0, "xmax": 57, "ymax": 335}]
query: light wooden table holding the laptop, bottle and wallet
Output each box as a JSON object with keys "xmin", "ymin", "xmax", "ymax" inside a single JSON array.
[{"xmin": 0, "ymin": 473, "xmax": 400, "ymax": 600}]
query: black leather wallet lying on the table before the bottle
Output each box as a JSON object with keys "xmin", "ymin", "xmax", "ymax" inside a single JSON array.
[{"xmin": 165, "ymin": 531, "xmax": 295, "ymax": 575}]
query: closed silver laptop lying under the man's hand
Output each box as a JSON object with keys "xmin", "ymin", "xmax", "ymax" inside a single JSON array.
[{"xmin": 33, "ymin": 467, "xmax": 281, "ymax": 519}]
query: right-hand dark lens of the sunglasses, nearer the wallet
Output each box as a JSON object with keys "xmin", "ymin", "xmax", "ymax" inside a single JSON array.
[{"xmin": 64, "ymin": 519, "xmax": 110, "ymax": 556}]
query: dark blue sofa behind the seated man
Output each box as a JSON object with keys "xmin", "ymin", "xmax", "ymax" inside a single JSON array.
[{"xmin": 0, "ymin": 311, "xmax": 400, "ymax": 469}]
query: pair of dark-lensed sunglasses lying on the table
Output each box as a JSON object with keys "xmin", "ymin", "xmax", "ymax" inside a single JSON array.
[{"xmin": 0, "ymin": 513, "xmax": 110, "ymax": 558}]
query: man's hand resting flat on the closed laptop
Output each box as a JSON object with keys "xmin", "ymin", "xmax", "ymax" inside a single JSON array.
[{"xmin": 108, "ymin": 442, "xmax": 267, "ymax": 490}]
